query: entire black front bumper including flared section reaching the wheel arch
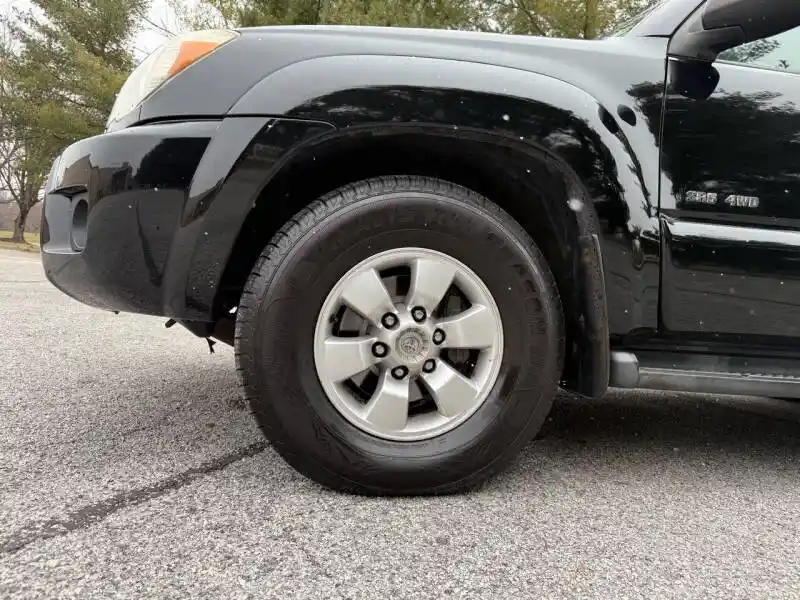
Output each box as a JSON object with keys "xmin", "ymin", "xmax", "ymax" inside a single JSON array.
[{"xmin": 42, "ymin": 116, "xmax": 335, "ymax": 324}]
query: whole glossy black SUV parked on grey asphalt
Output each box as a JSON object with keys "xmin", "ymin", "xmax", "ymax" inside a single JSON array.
[{"xmin": 42, "ymin": 0, "xmax": 800, "ymax": 494}]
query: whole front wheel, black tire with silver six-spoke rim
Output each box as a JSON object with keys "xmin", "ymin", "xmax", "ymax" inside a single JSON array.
[{"xmin": 236, "ymin": 177, "xmax": 563, "ymax": 495}]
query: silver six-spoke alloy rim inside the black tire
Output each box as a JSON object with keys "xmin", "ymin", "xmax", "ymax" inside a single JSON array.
[{"xmin": 314, "ymin": 248, "xmax": 503, "ymax": 441}]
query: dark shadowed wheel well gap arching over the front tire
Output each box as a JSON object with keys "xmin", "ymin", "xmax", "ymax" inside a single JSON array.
[{"xmin": 215, "ymin": 133, "xmax": 582, "ymax": 387}]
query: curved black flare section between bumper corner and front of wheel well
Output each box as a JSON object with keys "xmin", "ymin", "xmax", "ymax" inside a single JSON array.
[{"xmin": 163, "ymin": 117, "xmax": 335, "ymax": 324}]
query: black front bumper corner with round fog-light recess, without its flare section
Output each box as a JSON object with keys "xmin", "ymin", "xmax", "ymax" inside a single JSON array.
[{"xmin": 41, "ymin": 121, "xmax": 220, "ymax": 315}]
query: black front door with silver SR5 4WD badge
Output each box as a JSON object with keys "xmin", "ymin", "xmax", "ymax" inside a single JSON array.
[{"xmin": 660, "ymin": 28, "xmax": 800, "ymax": 352}]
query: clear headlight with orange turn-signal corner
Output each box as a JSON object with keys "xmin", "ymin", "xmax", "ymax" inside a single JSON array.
[{"xmin": 107, "ymin": 29, "xmax": 239, "ymax": 125}]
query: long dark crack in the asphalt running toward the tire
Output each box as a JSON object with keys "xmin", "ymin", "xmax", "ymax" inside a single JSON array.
[{"xmin": 0, "ymin": 441, "xmax": 269, "ymax": 554}]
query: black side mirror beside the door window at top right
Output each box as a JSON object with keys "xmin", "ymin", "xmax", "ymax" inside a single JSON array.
[{"xmin": 669, "ymin": 0, "xmax": 800, "ymax": 62}]
